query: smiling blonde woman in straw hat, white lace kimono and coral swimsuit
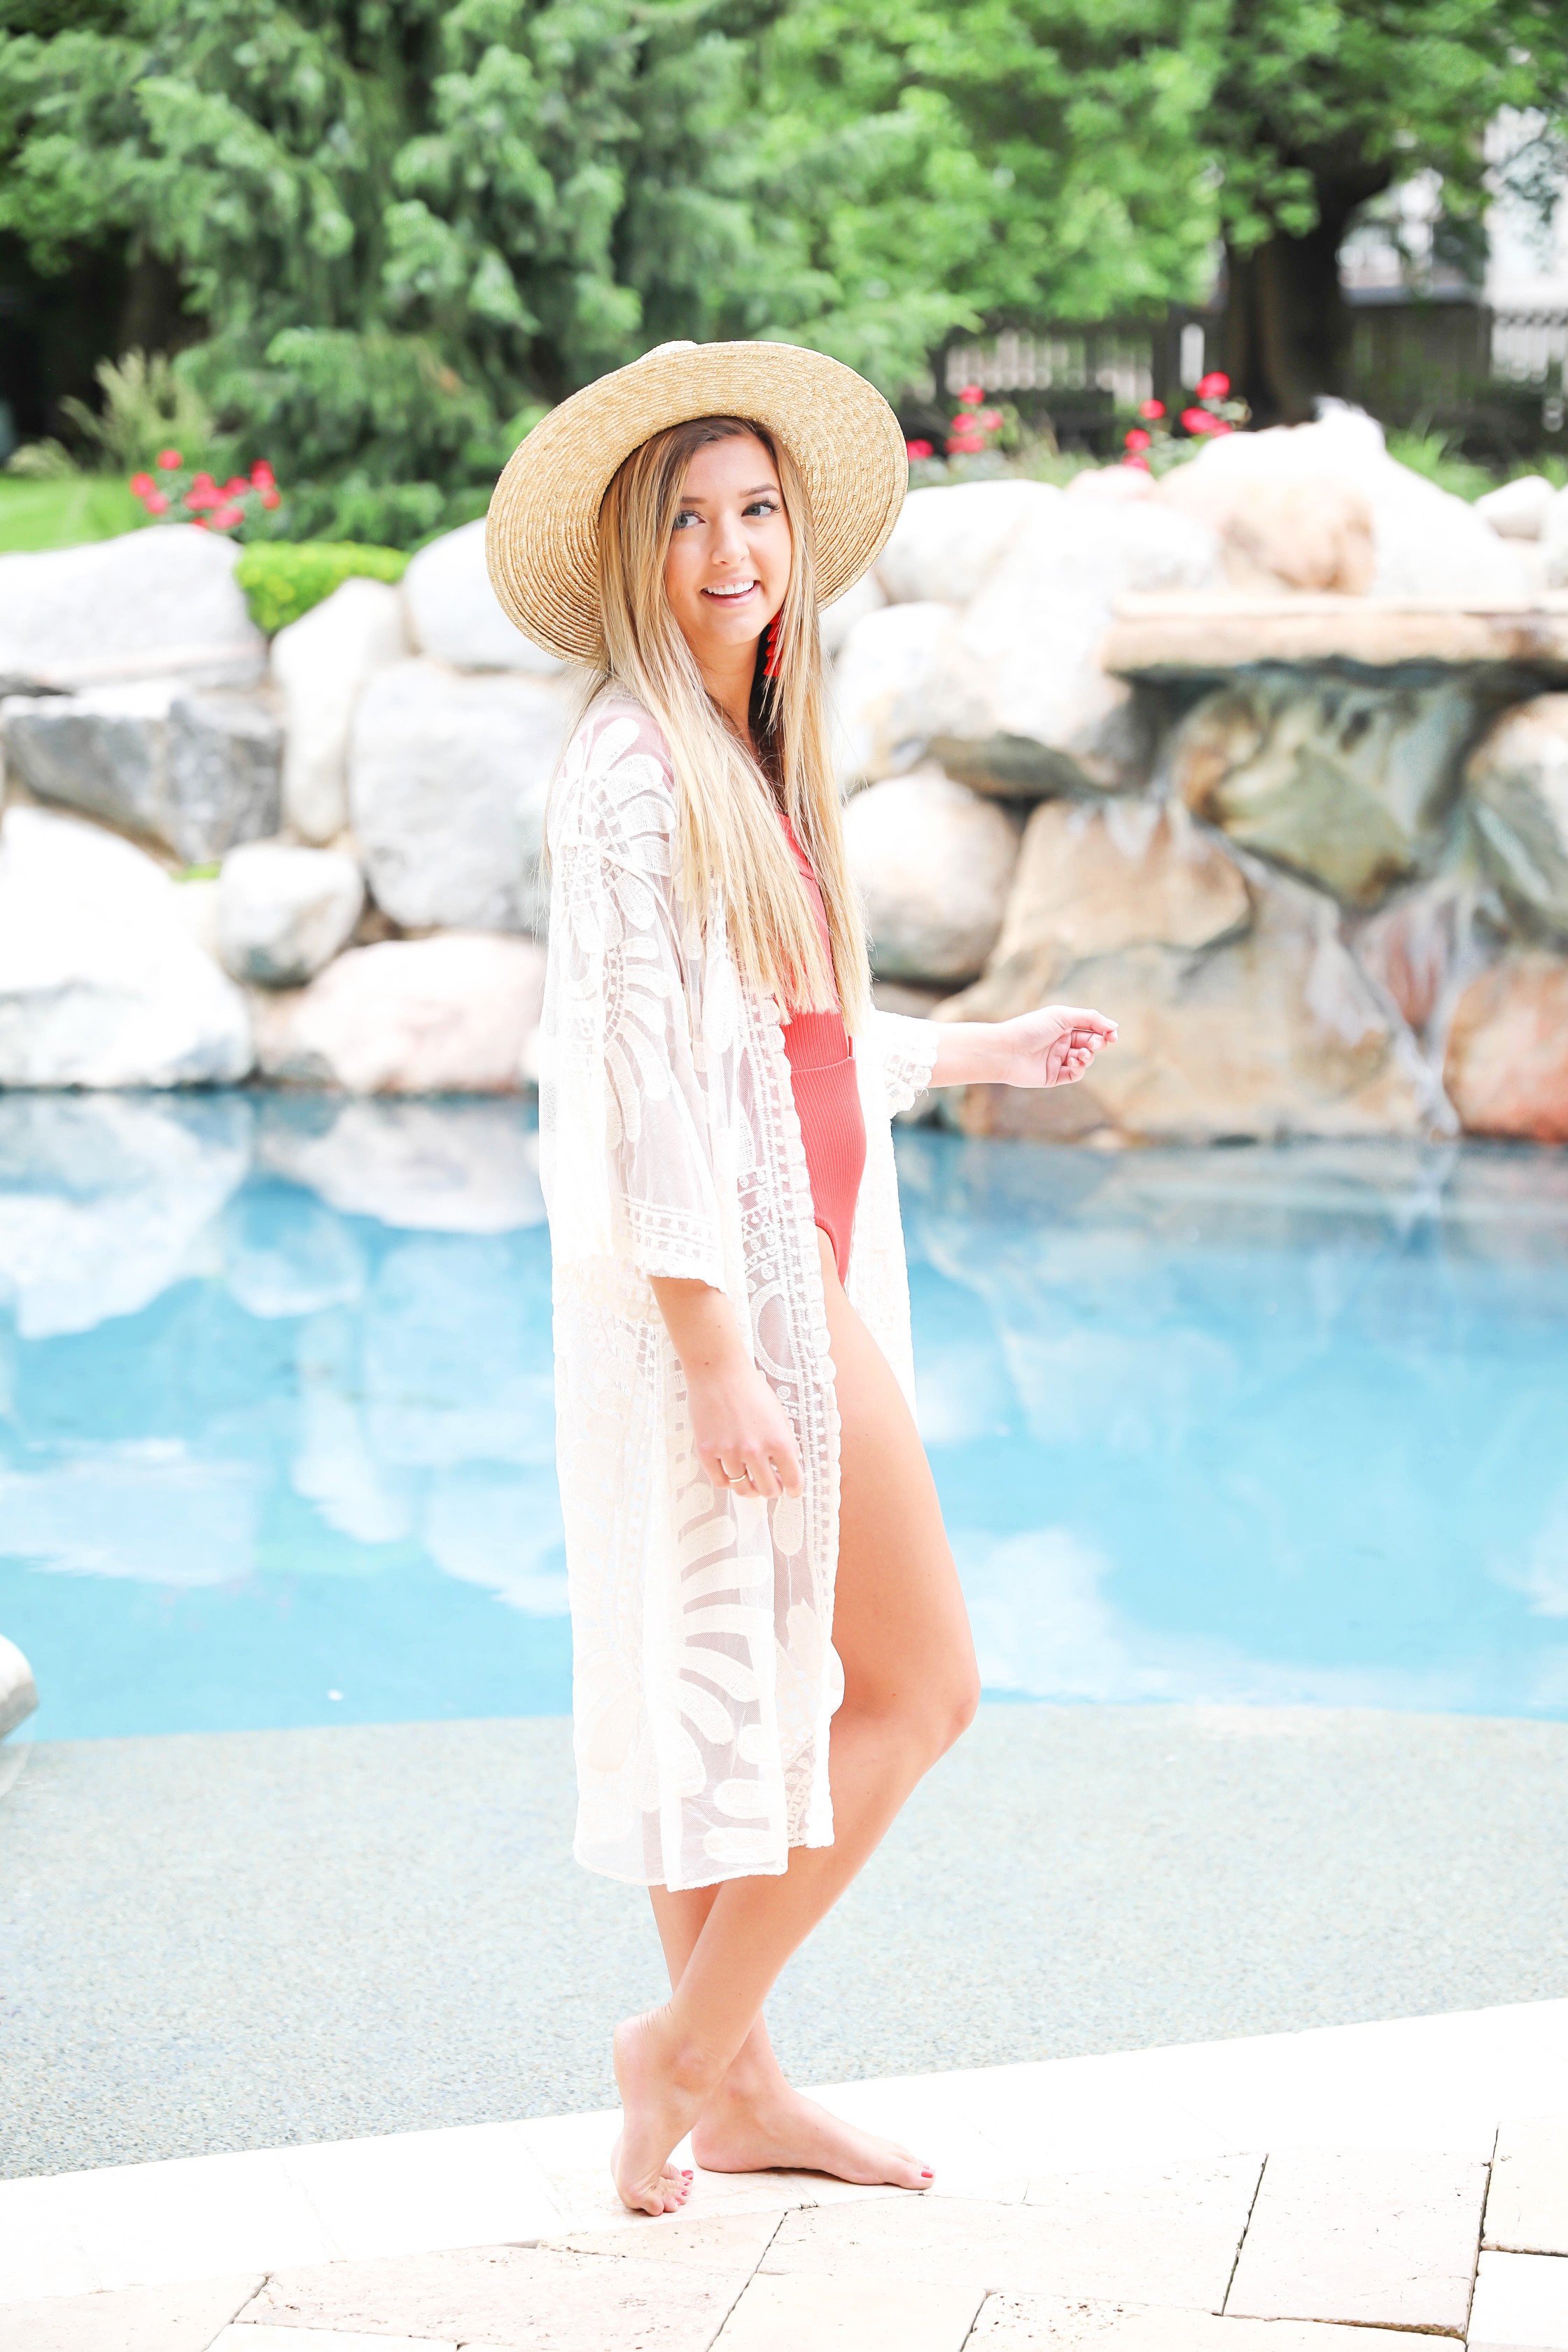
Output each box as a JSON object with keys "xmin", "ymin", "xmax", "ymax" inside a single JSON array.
[{"xmin": 489, "ymin": 344, "xmax": 1114, "ymax": 2213}]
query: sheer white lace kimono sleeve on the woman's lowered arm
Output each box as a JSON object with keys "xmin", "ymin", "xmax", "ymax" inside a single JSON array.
[{"xmin": 538, "ymin": 720, "xmax": 724, "ymax": 1289}]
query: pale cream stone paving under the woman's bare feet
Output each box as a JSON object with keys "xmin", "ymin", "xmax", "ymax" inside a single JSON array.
[{"xmin": 0, "ymin": 2001, "xmax": 1568, "ymax": 2352}]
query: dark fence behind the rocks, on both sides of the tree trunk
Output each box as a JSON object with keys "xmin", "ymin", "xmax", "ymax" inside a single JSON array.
[{"xmin": 943, "ymin": 299, "xmax": 1568, "ymax": 438}]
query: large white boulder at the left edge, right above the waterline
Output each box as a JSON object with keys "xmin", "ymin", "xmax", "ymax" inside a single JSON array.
[{"xmin": 0, "ymin": 809, "xmax": 251, "ymax": 1086}]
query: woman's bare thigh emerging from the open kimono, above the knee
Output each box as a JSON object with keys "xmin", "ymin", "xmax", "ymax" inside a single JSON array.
[{"xmin": 818, "ymin": 1233, "xmax": 973, "ymax": 1712}]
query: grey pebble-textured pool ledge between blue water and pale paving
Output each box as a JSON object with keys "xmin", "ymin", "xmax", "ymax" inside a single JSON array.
[{"xmin": 0, "ymin": 1705, "xmax": 1568, "ymax": 2176}]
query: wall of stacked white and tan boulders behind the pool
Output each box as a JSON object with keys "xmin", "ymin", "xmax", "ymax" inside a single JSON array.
[{"xmin": 0, "ymin": 412, "xmax": 1568, "ymax": 1143}]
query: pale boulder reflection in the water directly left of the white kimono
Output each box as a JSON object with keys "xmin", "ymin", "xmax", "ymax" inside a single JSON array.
[{"xmin": 256, "ymin": 1096, "xmax": 545, "ymax": 1233}]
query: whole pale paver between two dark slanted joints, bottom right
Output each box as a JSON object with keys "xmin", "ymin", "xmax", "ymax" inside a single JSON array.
[{"xmin": 1225, "ymin": 2150, "xmax": 1485, "ymax": 2335}]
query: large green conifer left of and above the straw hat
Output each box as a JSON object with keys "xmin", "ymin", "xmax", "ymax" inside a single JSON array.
[{"xmin": 0, "ymin": 0, "xmax": 769, "ymax": 541}]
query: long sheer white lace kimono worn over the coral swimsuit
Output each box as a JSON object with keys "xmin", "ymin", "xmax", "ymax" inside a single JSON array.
[{"xmin": 538, "ymin": 696, "xmax": 936, "ymax": 1886}]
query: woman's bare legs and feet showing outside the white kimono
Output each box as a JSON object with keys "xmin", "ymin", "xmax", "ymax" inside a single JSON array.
[{"xmin": 616, "ymin": 1242, "xmax": 978, "ymax": 2211}]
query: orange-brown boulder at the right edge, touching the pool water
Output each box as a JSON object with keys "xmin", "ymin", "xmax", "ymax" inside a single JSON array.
[{"xmin": 1443, "ymin": 953, "xmax": 1568, "ymax": 1143}]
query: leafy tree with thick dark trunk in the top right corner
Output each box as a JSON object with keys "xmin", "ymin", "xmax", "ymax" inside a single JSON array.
[{"xmin": 1201, "ymin": 0, "xmax": 1568, "ymax": 424}]
